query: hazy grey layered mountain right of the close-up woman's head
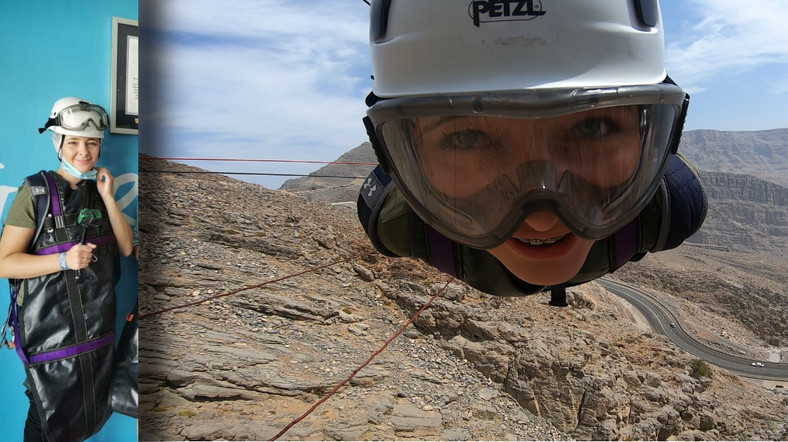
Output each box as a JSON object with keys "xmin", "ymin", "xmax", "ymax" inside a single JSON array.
[{"xmin": 679, "ymin": 129, "xmax": 788, "ymax": 259}]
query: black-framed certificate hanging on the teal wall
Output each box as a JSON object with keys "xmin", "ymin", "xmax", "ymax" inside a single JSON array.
[{"xmin": 109, "ymin": 17, "xmax": 139, "ymax": 135}]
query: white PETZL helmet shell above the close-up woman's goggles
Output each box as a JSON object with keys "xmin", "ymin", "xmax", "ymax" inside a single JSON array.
[{"xmin": 370, "ymin": 0, "xmax": 666, "ymax": 97}]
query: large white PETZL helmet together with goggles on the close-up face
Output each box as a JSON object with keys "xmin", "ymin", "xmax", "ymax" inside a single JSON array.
[{"xmin": 365, "ymin": 0, "xmax": 689, "ymax": 249}]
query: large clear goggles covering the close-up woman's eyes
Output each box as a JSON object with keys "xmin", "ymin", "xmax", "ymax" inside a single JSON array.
[{"xmin": 367, "ymin": 84, "xmax": 688, "ymax": 249}]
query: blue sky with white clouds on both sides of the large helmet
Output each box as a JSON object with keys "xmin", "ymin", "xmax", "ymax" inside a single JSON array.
[{"xmin": 140, "ymin": 0, "xmax": 788, "ymax": 188}]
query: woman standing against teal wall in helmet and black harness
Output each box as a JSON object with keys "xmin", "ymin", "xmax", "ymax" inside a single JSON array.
[{"xmin": 0, "ymin": 97, "xmax": 132, "ymax": 441}]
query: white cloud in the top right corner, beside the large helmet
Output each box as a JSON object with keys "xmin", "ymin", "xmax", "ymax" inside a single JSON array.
[{"xmin": 666, "ymin": 0, "xmax": 788, "ymax": 92}]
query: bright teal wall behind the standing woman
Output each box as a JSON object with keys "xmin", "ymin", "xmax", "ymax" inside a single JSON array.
[{"xmin": 0, "ymin": 0, "xmax": 138, "ymax": 441}]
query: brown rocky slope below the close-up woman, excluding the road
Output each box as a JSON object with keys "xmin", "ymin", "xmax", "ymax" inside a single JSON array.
[{"xmin": 139, "ymin": 158, "xmax": 788, "ymax": 440}]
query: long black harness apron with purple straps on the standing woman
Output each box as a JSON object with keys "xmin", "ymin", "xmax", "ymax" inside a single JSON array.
[{"xmin": 14, "ymin": 173, "xmax": 120, "ymax": 441}]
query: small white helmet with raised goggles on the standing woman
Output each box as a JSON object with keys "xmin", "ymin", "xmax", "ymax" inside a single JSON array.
[{"xmin": 38, "ymin": 97, "xmax": 109, "ymax": 138}]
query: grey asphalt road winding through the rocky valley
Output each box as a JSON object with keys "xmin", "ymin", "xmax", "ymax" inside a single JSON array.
[{"xmin": 597, "ymin": 278, "xmax": 788, "ymax": 381}]
